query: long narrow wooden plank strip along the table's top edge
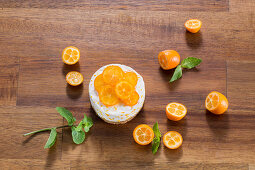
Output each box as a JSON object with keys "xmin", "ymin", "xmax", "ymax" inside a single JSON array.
[{"xmin": 0, "ymin": 0, "xmax": 228, "ymax": 11}]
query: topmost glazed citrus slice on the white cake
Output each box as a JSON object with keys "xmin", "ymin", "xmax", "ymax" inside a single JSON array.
[{"xmin": 103, "ymin": 65, "xmax": 124, "ymax": 86}]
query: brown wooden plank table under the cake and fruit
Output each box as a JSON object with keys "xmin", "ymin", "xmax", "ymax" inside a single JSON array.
[{"xmin": 0, "ymin": 0, "xmax": 255, "ymax": 169}]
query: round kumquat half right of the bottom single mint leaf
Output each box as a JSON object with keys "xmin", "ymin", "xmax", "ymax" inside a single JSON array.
[{"xmin": 163, "ymin": 131, "xmax": 183, "ymax": 149}]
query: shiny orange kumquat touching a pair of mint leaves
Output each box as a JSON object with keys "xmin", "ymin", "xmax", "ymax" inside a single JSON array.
[{"xmin": 158, "ymin": 50, "xmax": 180, "ymax": 70}]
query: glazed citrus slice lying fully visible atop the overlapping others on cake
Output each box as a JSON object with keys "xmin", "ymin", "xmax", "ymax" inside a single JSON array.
[{"xmin": 115, "ymin": 81, "xmax": 135, "ymax": 100}]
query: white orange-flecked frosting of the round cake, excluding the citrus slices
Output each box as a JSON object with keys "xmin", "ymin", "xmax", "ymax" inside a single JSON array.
[{"xmin": 89, "ymin": 64, "xmax": 145, "ymax": 124}]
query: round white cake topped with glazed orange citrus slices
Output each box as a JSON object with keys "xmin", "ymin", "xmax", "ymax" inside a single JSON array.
[{"xmin": 89, "ymin": 64, "xmax": 145, "ymax": 124}]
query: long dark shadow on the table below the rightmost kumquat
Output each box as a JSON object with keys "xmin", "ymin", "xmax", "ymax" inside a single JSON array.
[{"xmin": 205, "ymin": 110, "xmax": 229, "ymax": 142}]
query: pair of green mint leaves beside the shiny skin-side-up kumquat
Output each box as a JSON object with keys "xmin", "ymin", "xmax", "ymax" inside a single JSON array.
[{"xmin": 169, "ymin": 57, "xmax": 202, "ymax": 83}]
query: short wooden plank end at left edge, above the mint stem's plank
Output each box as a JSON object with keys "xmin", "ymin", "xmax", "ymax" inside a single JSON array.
[{"xmin": 0, "ymin": 56, "xmax": 19, "ymax": 106}]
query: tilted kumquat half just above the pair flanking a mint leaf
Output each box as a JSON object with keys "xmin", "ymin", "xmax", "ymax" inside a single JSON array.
[{"xmin": 166, "ymin": 102, "xmax": 187, "ymax": 121}]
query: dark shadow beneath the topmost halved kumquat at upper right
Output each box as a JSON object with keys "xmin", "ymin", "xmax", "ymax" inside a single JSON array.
[{"xmin": 185, "ymin": 31, "xmax": 203, "ymax": 49}]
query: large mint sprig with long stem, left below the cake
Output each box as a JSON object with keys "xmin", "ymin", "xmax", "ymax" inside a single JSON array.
[{"xmin": 24, "ymin": 107, "xmax": 93, "ymax": 149}]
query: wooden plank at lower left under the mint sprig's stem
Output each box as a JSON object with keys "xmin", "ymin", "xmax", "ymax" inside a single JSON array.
[{"xmin": 0, "ymin": 107, "xmax": 63, "ymax": 160}]
